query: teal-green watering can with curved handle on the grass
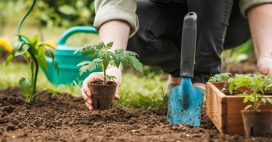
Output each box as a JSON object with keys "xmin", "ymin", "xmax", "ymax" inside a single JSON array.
[{"xmin": 42, "ymin": 26, "xmax": 98, "ymax": 85}]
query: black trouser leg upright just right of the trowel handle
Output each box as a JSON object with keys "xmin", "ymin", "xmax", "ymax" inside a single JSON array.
[{"xmin": 187, "ymin": 0, "xmax": 233, "ymax": 82}]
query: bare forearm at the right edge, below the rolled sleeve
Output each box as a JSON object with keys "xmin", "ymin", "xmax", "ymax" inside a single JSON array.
[{"xmin": 247, "ymin": 4, "xmax": 272, "ymax": 59}]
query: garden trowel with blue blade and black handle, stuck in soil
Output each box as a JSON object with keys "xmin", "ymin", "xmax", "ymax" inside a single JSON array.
[{"xmin": 167, "ymin": 12, "xmax": 203, "ymax": 126}]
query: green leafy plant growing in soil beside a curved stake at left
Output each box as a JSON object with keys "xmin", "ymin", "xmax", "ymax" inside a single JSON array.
[{"xmin": 6, "ymin": 35, "xmax": 58, "ymax": 103}]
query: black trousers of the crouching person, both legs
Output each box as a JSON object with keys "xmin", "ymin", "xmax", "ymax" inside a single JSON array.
[{"xmin": 128, "ymin": 0, "xmax": 249, "ymax": 82}]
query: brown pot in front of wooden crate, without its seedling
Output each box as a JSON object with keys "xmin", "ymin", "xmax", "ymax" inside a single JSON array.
[{"xmin": 241, "ymin": 110, "xmax": 272, "ymax": 137}]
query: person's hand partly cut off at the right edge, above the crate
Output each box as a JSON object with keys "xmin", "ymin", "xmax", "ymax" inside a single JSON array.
[{"xmin": 257, "ymin": 57, "xmax": 272, "ymax": 75}]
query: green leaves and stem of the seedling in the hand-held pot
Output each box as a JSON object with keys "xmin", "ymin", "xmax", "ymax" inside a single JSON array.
[{"xmin": 75, "ymin": 42, "xmax": 143, "ymax": 85}]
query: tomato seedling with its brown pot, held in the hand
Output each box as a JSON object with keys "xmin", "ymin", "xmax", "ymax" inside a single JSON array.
[{"xmin": 76, "ymin": 42, "xmax": 143, "ymax": 110}]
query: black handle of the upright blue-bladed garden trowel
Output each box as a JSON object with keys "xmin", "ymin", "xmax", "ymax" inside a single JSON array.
[{"xmin": 180, "ymin": 12, "xmax": 197, "ymax": 78}]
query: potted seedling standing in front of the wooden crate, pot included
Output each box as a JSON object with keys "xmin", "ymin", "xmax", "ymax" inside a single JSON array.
[{"xmin": 233, "ymin": 74, "xmax": 272, "ymax": 136}]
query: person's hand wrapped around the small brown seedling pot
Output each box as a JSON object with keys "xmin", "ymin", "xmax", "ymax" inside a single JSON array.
[{"xmin": 81, "ymin": 67, "xmax": 121, "ymax": 111}]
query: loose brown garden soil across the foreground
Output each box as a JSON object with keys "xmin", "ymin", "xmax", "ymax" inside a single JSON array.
[{"xmin": 0, "ymin": 88, "xmax": 271, "ymax": 142}]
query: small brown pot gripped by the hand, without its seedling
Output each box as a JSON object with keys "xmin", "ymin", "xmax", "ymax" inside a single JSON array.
[{"xmin": 89, "ymin": 81, "xmax": 117, "ymax": 110}]
